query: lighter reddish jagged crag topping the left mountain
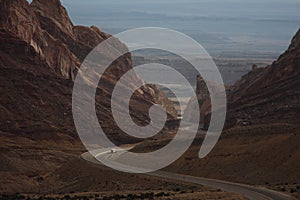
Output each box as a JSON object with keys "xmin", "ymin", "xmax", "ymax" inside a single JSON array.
[{"xmin": 0, "ymin": 0, "xmax": 80, "ymax": 79}]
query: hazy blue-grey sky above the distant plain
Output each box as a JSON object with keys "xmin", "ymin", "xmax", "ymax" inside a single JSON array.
[{"xmin": 52, "ymin": 0, "xmax": 300, "ymax": 55}]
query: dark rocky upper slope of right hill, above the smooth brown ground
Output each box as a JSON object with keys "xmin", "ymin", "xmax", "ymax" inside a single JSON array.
[{"xmin": 227, "ymin": 30, "xmax": 300, "ymax": 126}]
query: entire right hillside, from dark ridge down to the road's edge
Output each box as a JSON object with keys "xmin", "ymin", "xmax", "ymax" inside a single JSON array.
[{"xmin": 164, "ymin": 30, "xmax": 300, "ymax": 193}]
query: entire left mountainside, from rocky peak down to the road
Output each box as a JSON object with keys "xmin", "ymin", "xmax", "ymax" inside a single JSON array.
[{"xmin": 0, "ymin": 0, "xmax": 176, "ymax": 192}]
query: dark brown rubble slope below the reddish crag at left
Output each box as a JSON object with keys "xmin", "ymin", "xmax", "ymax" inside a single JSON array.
[{"xmin": 0, "ymin": 27, "xmax": 75, "ymax": 138}]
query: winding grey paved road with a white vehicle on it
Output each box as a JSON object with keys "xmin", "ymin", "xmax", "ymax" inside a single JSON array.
[{"xmin": 81, "ymin": 151, "xmax": 294, "ymax": 200}]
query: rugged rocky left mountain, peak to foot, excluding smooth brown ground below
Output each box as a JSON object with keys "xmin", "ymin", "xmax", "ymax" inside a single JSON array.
[{"xmin": 0, "ymin": 0, "xmax": 176, "ymax": 145}]
